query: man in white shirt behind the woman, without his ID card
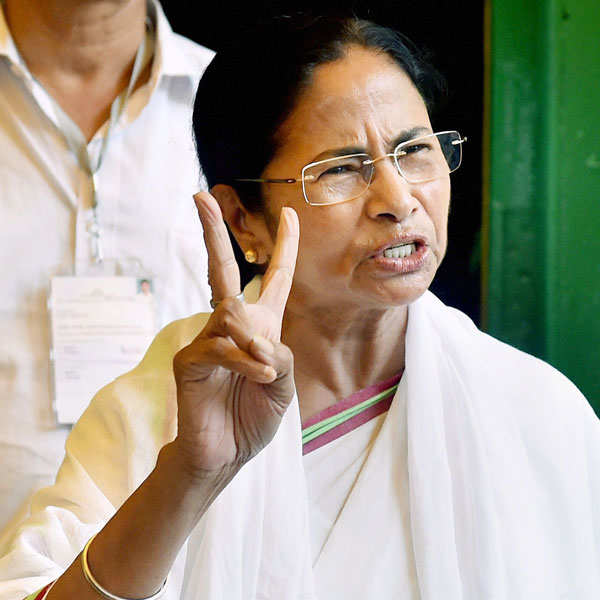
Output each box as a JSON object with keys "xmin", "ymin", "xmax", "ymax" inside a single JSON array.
[{"xmin": 0, "ymin": 0, "xmax": 213, "ymax": 527}]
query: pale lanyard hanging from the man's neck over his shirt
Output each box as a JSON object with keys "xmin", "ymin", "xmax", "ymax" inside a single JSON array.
[{"xmin": 48, "ymin": 21, "xmax": 154, "ymax": 264}]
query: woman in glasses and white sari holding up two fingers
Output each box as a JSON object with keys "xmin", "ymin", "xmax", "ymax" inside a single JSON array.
[{"xmin": 0, "ymin": 12, "xmax": 600, "ymax": 600}]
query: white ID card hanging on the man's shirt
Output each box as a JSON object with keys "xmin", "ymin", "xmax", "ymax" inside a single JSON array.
[{"xmin": 48, "ymin": 277, "xmax": 157, "ymax": 424}]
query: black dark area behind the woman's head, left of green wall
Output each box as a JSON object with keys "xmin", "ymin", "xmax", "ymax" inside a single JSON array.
[{"xmin": 163, "ymin": 0, "xmax": 483, "ymax": 323}]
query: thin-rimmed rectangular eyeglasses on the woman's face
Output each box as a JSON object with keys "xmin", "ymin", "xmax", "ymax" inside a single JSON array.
[{"xmin": 236, "ymin": 131, "xmax": 467, "ymax": 206}]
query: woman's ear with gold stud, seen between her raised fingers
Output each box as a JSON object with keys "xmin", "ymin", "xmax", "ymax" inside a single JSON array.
[{"xmin": 210, "ymin": 183, "xmax": 273, "ymax": 264}]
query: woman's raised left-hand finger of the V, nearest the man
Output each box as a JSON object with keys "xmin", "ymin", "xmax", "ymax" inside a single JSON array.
[{"xmin": 194, "ymin": 192, "xmax": 240, "ymax": 302}]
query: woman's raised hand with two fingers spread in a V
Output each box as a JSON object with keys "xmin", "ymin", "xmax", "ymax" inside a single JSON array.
[{"xmin": 173, "ymin": 192, "xmax": 299, "ymax": 480}]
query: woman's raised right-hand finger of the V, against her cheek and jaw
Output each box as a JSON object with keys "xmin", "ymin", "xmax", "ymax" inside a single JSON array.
[{"xmin": 258, "ymin": 206, "xmax": 300, "ymax": 321}]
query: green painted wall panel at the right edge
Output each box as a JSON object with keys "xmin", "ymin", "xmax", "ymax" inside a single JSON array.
[{"xmin": 482, "ymin": 0, "xmax": 600, "ymax": 414}]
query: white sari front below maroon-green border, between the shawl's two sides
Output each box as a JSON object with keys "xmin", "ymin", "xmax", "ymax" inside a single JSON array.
[{"xmin": 303, "ymin": 379, "xmax": 419, "ymax": 600}]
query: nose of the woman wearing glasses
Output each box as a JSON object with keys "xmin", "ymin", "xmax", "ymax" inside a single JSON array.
[{"xmin": 365, "ymin": 160, "xmax": 419, "ymax": 223}]
